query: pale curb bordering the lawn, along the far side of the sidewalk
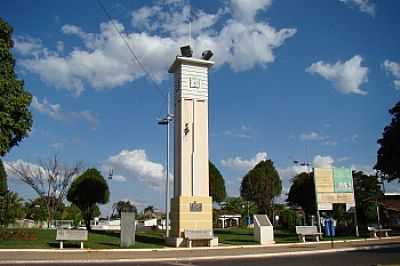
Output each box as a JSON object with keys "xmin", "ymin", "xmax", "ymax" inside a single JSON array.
[{"xmin": 0, "ymin": 236, "xmax": 400, "ymax": 253}]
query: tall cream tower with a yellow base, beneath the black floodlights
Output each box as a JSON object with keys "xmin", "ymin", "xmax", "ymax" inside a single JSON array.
[{"xmin": 168, "ymin": 52, "xmax": 218, "ymax": 247}]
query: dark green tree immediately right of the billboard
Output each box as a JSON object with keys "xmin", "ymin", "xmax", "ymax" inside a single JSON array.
[{"xmin": 353, "ymin": 171, "xmax": 382, "ymax": 228}]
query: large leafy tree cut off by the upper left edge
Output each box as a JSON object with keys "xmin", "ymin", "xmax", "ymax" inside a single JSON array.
[{"xmin": 0, "ymin": 18, "xmax": 32, "ymax": 156}]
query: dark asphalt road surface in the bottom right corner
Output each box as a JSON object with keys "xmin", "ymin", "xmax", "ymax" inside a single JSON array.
[{"xmin": 1, "ymin": 247, "xmax": 400, "ymax": 266}]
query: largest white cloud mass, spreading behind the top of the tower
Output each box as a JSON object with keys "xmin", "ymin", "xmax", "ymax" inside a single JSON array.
[{"xmin": 19, "ymin": 0, "xmax": 296, "ymax": 96}]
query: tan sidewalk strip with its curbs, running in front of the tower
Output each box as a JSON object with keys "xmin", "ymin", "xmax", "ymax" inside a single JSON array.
[{"xmin": 0, "ymin": 237, "xmax": 400, "ymax": 265}]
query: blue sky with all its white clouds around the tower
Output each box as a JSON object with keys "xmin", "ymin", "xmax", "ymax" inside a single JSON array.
[{"xmin": 0, "ymin": 0, "xmax": 400, "ymax": 215}]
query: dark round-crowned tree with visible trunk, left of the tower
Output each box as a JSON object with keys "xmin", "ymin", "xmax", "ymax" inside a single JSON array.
[{"xmin": 67, "ymin": 168, "xmax": 110, "ymax": 230}]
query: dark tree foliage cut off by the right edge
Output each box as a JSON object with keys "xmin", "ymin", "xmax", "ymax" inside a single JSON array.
[{"xmin": 374, "ymin": 101, "xmax": 400, "ymax": 182}]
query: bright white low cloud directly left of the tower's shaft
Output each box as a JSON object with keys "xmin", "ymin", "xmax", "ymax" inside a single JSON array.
[{"xmin": 102, "ymin": 149, "xmax": 165, "ymax": 190}]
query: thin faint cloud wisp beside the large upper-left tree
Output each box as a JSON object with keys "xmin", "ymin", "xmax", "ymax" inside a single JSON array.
[{"xmin": 31, "ymin": 96, "xmax": 99, "ymax": 128}]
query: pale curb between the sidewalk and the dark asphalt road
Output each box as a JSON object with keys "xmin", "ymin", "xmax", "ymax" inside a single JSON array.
[{"xmin": 0, "ymin": 244, "xmax": 400, "ymax": 265}]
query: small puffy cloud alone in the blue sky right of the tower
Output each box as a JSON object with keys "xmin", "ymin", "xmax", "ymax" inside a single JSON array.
[{"xmin": 306, "ymin": 55, "xmax": 368, "ymax": 95}]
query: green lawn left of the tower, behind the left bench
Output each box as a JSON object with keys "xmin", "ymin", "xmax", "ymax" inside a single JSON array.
[{"xmin": 0, "ymin": 229, "xmax": 165, "ymax": 249}]
